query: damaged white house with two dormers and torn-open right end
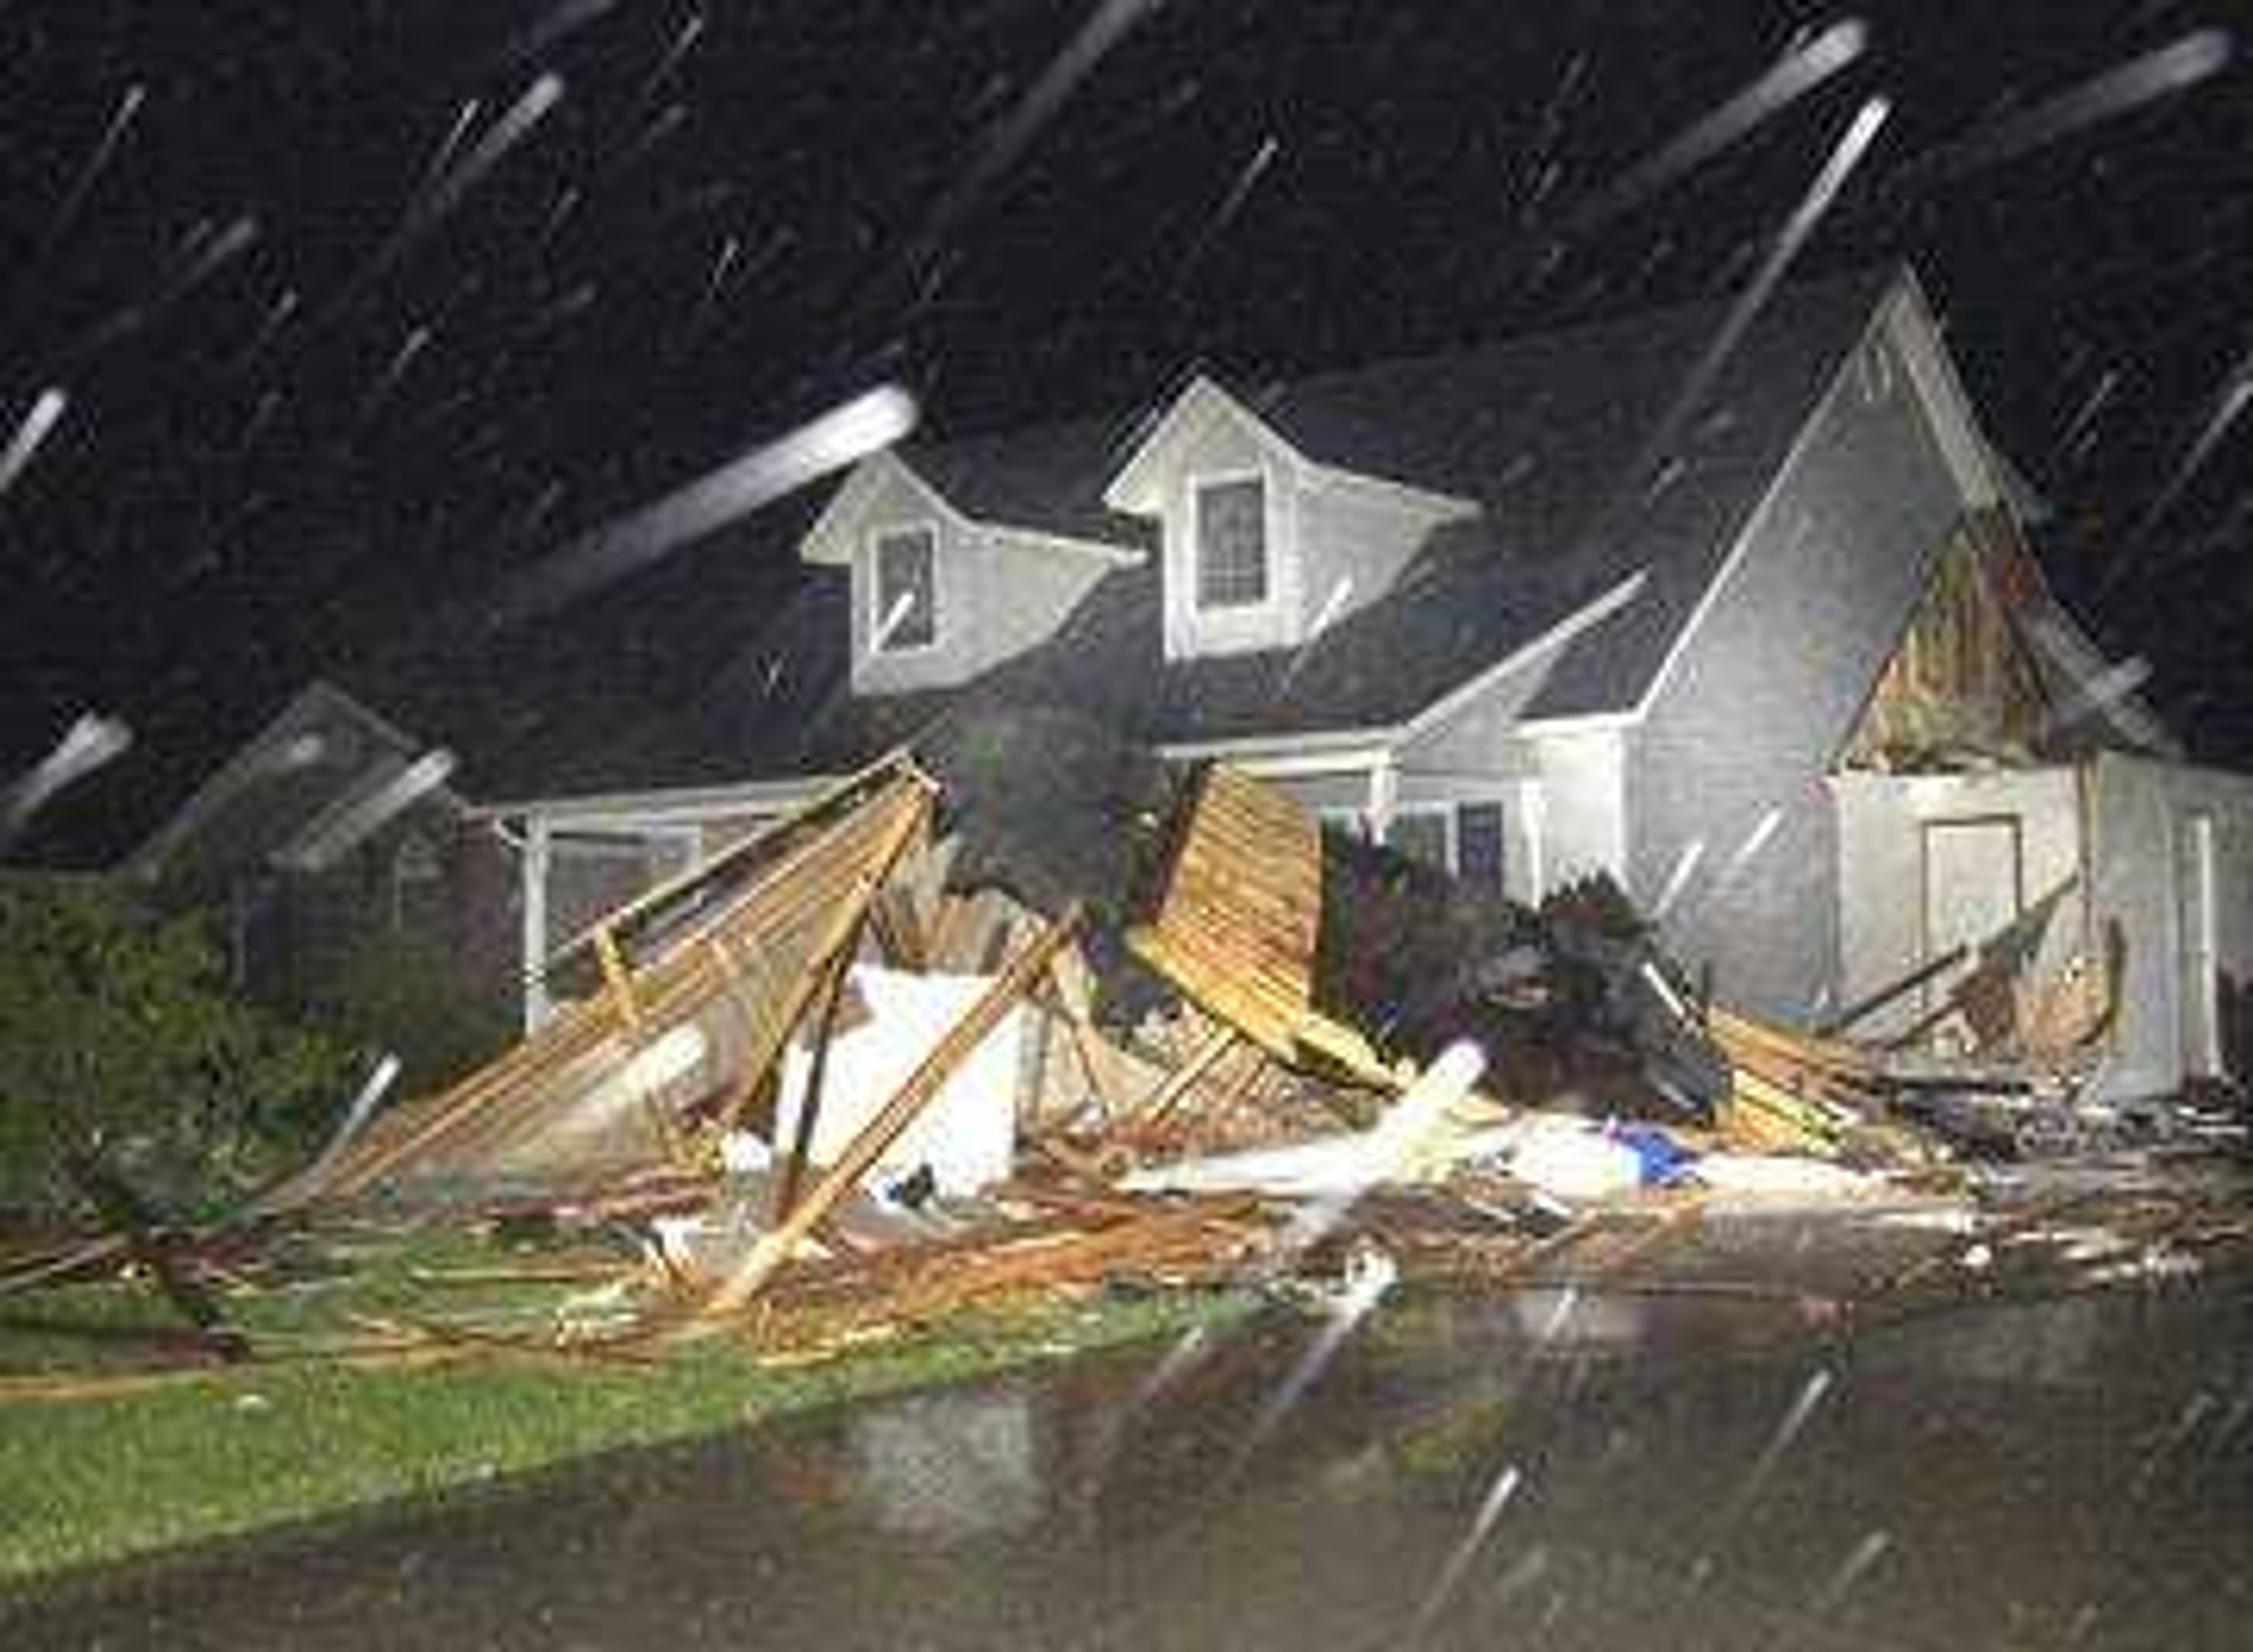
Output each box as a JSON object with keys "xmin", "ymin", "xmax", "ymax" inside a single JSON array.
[{"xmin": 101, "ymin": 268, "xmax": 2253, "ymax": 1095}]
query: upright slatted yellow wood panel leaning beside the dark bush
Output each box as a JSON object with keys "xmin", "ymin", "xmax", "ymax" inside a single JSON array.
[{"xmin": 1126, "ymin": 766, "xmax": 1397, "ymax": 1084}]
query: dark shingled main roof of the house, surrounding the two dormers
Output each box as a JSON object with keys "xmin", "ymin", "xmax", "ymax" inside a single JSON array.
[{"xmin": 502, "ymin": 270, "xmax": 1895, "ymax": 795}]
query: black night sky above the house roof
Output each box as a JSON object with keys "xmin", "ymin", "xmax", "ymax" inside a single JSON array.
[{"xmin": 0, "ymin": 0, "xmax": 2253, "ymax": 787}]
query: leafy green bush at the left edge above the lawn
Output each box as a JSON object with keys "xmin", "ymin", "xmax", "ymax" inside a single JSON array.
[{"xmin": 0, "ymin": 879, "xmax": 356, "ymax": 1215}]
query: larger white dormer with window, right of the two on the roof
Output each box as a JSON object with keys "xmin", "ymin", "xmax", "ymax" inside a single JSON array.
[{"xmin": 1104, "ymin": 377, "xmax": 1478, "ymax": 661}]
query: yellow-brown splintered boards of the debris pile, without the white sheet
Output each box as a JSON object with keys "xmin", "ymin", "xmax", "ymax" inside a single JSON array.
[{"xmin": 13, "ymin": 753, "xmax": 2163, "ymax": 1388}]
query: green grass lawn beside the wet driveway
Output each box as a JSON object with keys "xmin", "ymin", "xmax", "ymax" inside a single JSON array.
[{"xmin": 0, "ymin": 1240, "xmax": 1250, "ymax": 1587}]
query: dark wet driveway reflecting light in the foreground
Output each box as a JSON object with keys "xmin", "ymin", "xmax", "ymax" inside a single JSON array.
[{"xmin": 0, "ymin": 1285, "xmax": 2253, "ymax": 1652}]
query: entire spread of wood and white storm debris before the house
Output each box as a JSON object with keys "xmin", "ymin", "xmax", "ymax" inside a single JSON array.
[{"xmin": 0, "ymin": 755, "xmax": 2253, "ymax": 1397}]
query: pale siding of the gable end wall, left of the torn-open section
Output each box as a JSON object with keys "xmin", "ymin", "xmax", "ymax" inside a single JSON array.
[{"xmin": 1626, "ymin": 299, "xmax": 1967, "ymax": 1021}]
